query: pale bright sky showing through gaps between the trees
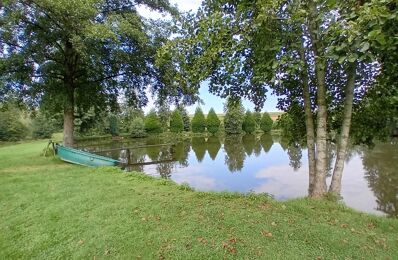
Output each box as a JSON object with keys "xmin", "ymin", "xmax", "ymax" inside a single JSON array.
[{"xmin": 137, "ymin": 0, "xmax": 279, "ymax": 114}]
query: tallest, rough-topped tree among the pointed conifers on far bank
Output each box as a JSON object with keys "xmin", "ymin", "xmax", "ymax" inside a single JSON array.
[{"xmin": 224, "ymin": 98, "xmax": 245, "ymax": 134}]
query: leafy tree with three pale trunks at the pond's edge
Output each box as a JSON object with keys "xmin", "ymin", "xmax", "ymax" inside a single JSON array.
[{"xmin": 163, "ymin": 0, "xmax": 398, "ymax": 198}]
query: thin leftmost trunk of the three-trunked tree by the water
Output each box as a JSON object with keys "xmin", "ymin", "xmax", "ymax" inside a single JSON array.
[{"xmin": 300, "ymin": 43, "xmax": 316, "ymax": 194}]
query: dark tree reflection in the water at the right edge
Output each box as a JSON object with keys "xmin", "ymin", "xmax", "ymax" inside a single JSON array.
[{"xmin": 362, "ymin": 144, "xmax": 398, "ymax": 217}]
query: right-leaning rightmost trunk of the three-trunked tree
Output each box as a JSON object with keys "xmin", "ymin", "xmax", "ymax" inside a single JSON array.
[{"xmin": 329, "ymin": 63, "xmax": 356, "ymax": 195}]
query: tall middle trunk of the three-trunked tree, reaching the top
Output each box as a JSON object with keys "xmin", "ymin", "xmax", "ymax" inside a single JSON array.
[{"xmin": 308, "ymin": 1, "xmax": 328, "ymax": 198}]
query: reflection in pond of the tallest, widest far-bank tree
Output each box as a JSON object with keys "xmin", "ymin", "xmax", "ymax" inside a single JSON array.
[{"xmin": 224, "ymin": 136, "xmax": 246, "ymax": 172}]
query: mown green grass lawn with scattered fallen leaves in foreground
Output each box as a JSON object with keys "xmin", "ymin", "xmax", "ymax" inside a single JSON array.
[{"xmin": 0, "ymin": 141, "xmax": 398, "ymax": 259}]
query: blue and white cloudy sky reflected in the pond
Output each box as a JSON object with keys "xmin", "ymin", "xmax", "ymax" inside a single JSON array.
[{"xmin": 84, "ymin": 140, "xmax": 394, "ymax": 217}]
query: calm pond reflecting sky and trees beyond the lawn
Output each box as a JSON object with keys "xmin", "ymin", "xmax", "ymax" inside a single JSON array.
[{"xmin": 78, "ymin": 135, "xmax": 398, "ymax": 217}]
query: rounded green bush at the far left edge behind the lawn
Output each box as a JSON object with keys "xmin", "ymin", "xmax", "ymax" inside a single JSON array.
[{"xmin": 0, "ymin": 108, "xmax": 28, "ymax": 141}]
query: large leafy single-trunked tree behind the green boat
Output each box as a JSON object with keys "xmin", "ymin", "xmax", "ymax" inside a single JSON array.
[{"xmin": 0, "ymin": 0, "xmax": 176, "ymax": 146}]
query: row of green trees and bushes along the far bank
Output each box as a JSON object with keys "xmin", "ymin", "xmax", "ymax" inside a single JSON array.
[{"xmin": 0, "ymin": 101, "xmax": 281, "ymax": 141}]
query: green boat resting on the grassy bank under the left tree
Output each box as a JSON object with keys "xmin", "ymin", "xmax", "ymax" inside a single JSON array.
[{"xmin": 55, "ymin": 144, "xmax": 120, "ymax": 167}]
